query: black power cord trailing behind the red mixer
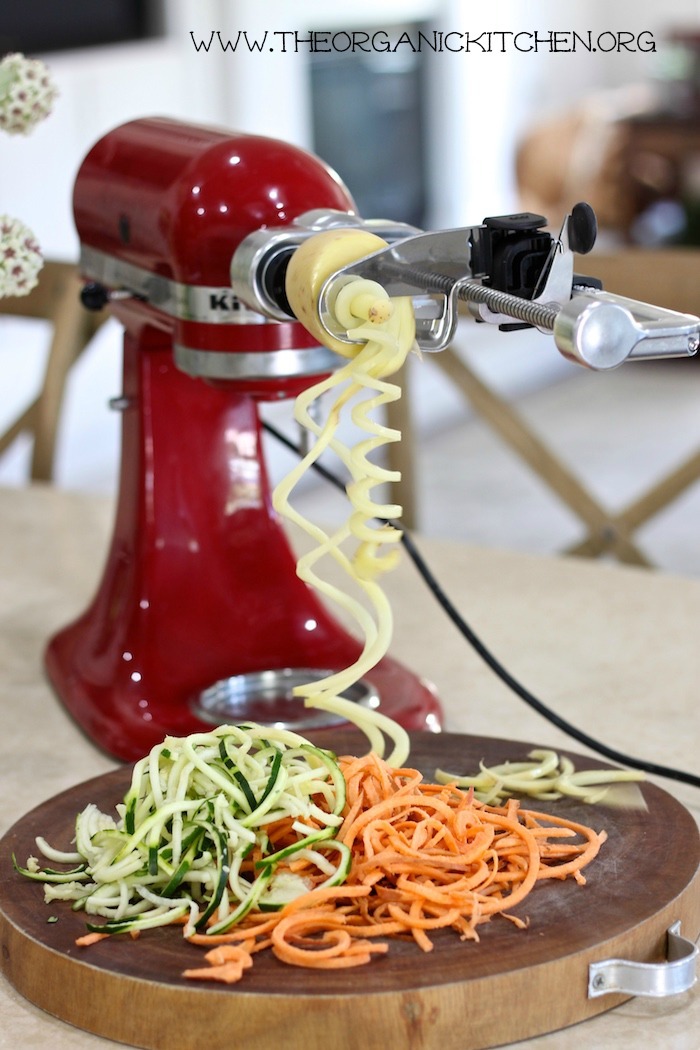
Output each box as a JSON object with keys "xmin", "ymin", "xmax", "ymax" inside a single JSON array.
[{"xmin": 262, "ymin": 422, "xmax": 700, "ymax": 788}]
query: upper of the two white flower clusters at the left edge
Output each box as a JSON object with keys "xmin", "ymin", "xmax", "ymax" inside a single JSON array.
[{"xmin": 0, "ymin": 53, "xmax": 58, "ymax": 134}]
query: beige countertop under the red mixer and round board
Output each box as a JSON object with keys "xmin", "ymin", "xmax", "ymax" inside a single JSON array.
[{"xmin": 0, "ymin": 487, "xmax": 700, "ymax": 1050}]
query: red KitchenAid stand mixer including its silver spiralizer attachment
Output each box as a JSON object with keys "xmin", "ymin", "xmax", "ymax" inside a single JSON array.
[{"xmin": 46, "ymin": 119, "xmax": 700, "ymax": 759}]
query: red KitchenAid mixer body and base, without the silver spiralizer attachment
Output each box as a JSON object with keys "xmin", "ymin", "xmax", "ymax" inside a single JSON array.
[{"xmin": 45, "ymin": 119, "xmax": 441, "ymax": 760}]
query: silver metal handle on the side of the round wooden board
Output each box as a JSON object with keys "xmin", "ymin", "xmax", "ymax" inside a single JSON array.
[{"xmin": 588, "ymin": 922, "xmax": 698, "ymax": 999}]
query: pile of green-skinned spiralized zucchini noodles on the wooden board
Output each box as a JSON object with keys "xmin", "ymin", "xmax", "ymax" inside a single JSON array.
[{"xmin": 15, "ymin": 726, "xmax": 349, "ymax": 937}]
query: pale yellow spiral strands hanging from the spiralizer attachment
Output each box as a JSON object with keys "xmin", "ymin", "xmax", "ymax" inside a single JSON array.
[{"xmin": 273, "ymin": 279, "xmax": 415, "ymax": 765}]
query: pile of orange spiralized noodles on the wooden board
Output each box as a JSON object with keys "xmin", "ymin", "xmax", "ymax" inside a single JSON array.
[{"xmin": 178, "ymin": 753, "xmax": 606, "ymax": 983}]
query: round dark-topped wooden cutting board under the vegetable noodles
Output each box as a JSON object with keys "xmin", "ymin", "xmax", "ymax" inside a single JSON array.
[{"xmin": 0, "ymin": 733, "xmax": 700, "ymax": 1050}]
